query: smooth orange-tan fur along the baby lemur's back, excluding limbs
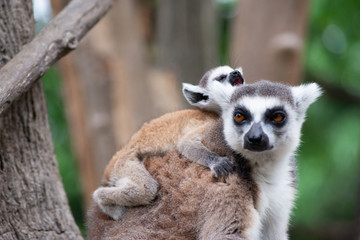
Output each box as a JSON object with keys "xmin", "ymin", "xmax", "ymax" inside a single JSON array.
[{"xmin": 104, "ymin": 110, "xmax": 219, "ymax": 184}]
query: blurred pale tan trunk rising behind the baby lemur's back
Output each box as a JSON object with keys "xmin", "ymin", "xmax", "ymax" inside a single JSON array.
[{"xmin": 107, "ymin": 0, "xmax": 155, "ymax": 145}]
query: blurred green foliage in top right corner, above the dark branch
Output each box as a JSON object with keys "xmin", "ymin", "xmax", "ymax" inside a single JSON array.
[{"xmin": 305, "ymin": 0, "xmax": 360, "ymax": 93}]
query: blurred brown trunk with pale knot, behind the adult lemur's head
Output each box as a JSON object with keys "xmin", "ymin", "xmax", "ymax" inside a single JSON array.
[{"xmin": 230, "ymin": 0, "xmax": 308, "ymax": 84}]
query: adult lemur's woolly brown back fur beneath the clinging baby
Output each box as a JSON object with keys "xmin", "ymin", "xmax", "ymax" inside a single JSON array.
[{"xmin": 88, "ymin": 121, "xmax": 257, "ymax": 240}]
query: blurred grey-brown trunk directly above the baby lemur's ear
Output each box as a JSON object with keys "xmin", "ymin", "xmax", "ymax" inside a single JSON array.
[{"xmin": 156, "ymin": 0, "xmax": 219, "ymax": 87}]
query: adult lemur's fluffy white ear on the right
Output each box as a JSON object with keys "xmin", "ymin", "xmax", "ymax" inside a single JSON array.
[{"xmin": 291, "ymin": 83, "xmax": 322, "ymax": 113}]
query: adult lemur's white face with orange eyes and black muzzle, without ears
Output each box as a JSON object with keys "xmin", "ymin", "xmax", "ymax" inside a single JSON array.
[{"xmin": 223, "ymin": 96, "xmax": 299, "ymax": 156}]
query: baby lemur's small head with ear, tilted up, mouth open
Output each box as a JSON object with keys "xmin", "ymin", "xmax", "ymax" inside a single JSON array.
[{"xmin": 183, "ymin": 66, "xmax": 244, "ymax": 113}]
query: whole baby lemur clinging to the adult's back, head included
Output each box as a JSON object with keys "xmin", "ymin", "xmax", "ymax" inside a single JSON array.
[{"xmin": 93, "ymin": 66, "xmax": 244, "ymax": 220}]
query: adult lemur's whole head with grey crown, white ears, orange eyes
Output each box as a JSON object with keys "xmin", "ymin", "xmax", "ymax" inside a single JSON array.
[{"xmin": 212, "ymin": 81, "xmax": 321, "ymax": 161}]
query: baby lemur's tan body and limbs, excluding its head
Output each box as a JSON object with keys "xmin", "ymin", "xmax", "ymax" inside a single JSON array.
[{"xmin": 93, "ymin": 110, "xmax": 224, "ymax": 220}]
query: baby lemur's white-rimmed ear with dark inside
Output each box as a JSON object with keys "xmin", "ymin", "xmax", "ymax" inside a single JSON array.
[{"xmin": 183, "ymin": 83, "xmax": 210, "ymax": 108}]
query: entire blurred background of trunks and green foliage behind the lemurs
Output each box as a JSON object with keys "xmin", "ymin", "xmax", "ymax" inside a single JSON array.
[{"xmin": 33, "ymin": 0, "xmax": 360, "ymax": 240}]
